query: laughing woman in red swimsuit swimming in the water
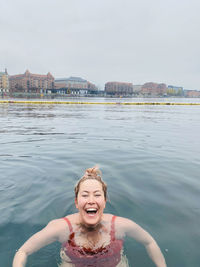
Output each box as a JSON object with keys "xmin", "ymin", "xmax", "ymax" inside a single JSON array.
[{"xmin": 13, "ymin": 167, "xmax": 166, "ymax": 267}]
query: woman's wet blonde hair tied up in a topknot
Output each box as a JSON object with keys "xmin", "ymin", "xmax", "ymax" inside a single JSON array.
[{"xmin": 74, "ymin": 166, "xmax": 107, "ymax": 200}]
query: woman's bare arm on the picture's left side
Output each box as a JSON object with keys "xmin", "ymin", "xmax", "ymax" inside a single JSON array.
[{"xmin": 13, "ymin": 220, "xmax": 65, "ymax": 267}]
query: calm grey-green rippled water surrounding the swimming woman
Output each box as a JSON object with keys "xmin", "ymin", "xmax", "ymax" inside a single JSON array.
[{"xmin": 0, "ymin": 99, "xmax": 200, "ymax": 267}]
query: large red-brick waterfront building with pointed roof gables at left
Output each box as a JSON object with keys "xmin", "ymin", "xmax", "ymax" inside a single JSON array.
[{"xmin": 9, "ymin": 70, "xmax": 54, "ymax": 93}]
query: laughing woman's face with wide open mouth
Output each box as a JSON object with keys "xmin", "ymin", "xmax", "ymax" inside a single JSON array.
[{"xmin": 75, "ymin": 179, "xmax": 106, "ymax": 227}]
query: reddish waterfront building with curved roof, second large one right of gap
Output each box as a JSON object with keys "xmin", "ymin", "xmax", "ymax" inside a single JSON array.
[{"xmin": 141, "ymin": 82, "xmax": 167, "ymax": 96}]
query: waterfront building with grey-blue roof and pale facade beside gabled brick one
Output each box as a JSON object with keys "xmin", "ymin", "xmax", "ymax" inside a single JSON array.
[{"xmin": 54, "ymin": 76, "xmax": 98, "ymax": 95}]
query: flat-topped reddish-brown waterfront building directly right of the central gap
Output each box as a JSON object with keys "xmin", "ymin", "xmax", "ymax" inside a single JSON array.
[{"xmin": 105, "ymin": 82, "xmax": 133, "ymax": 96}]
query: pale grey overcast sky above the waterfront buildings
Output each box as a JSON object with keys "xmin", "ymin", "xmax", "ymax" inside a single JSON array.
[{"xmin": 0, "ymin": 0, "xmax": 200, "ymax": 90}]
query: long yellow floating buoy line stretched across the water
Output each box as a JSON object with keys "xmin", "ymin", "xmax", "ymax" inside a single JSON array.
[{"xmin": 0, "ymin": 100, "xmax": 200, "ymax": 106}]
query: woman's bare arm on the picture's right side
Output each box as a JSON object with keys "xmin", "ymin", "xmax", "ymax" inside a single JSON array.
[{"xmin": 118, "ymin": 217, "xmax": 167, "ymax": 267}]
